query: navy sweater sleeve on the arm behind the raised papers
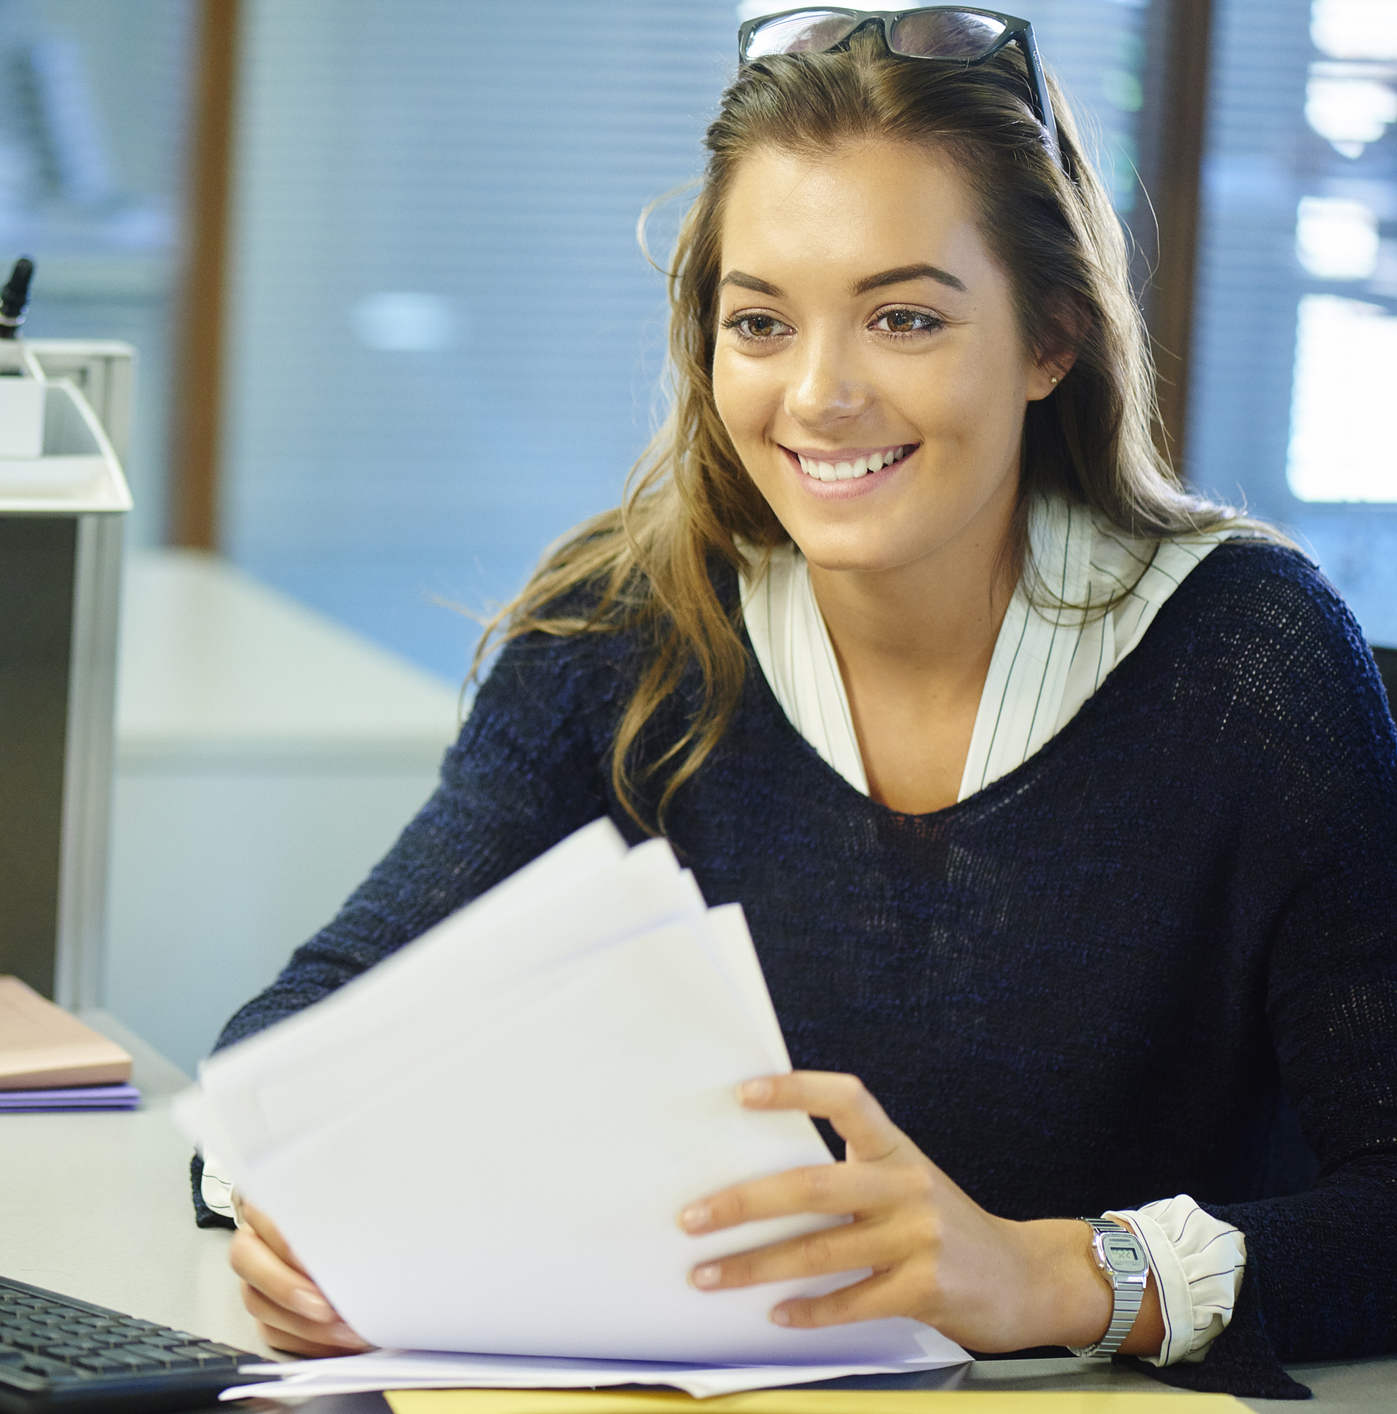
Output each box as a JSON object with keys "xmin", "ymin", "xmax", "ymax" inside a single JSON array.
[{"xmin": 192, "ymin": 633, "xmax": 619, "ymax": 1227}]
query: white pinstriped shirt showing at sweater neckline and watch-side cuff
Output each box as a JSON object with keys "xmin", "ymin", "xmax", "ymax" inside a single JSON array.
[{"xmin": 742, "ymin": 501, "xmax": 1247, "ymax": 1365}]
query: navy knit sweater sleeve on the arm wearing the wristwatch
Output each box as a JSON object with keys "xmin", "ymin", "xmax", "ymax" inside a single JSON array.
[{"xmin": 1136, "ymin": 557, "xmax": 1397, "ymax": 1397}]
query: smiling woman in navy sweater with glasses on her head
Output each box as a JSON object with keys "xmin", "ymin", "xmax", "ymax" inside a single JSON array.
[{"xmin": 205, "ymin": 10, "xmax": 1397, "ymax": 1396}]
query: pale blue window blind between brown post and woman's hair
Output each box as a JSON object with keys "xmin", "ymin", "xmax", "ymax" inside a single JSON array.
[{"xmin": 223, "ymin": 0, "xmax": 735, "ymax": 679}]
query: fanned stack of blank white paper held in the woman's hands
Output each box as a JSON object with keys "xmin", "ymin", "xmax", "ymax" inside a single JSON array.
[{"xmin": 168, "ymin": 822, "xmax": 964, "ymax": 1383}]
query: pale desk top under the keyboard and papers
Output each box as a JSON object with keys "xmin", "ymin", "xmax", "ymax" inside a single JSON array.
[{"xmin": 0, "ymin": 1012, "xmax": 1397, "ymax": 1414}]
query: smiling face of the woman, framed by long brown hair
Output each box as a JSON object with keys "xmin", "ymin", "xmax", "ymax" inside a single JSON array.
[{"xmin": 713, "ymin": 141, "xmax": 1060, "ymax": 571}]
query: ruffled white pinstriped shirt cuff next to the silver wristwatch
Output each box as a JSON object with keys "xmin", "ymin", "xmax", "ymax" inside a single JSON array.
[{"xmin": 1103, "ymin": 1193, "xmax": 1247, "ymax": 1365}]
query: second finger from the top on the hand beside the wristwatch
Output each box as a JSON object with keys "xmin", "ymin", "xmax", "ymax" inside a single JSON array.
[{"xmin": 679, "ymin": 1162, "xmax": 933, "ymax": 1233}]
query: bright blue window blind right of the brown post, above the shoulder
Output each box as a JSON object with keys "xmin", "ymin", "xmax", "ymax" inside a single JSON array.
[{"xmin": 1189, "ymin": 0, "xmax": 1397, "ymax": 645}]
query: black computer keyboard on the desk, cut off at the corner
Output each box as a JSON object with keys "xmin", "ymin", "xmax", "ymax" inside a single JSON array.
[{"xmin": 0, "ymin": 1277, "xmax": 272, "ymax": 1414}]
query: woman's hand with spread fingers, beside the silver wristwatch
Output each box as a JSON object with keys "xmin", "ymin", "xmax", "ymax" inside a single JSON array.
[{"xmin": 679, "ymin": 1070, "xmax": 1162, "ymax": 1353}]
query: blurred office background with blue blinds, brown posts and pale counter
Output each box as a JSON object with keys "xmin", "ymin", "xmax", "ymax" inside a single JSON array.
[{"xmin": 0, "ymin": 0, "xmax": 1397, "ymax": 1065}]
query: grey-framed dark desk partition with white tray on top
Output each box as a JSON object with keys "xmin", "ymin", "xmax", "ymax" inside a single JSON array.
[{"xmin": 0, "ymin": 341, "xmax": 133, "ymax": 1007}]
